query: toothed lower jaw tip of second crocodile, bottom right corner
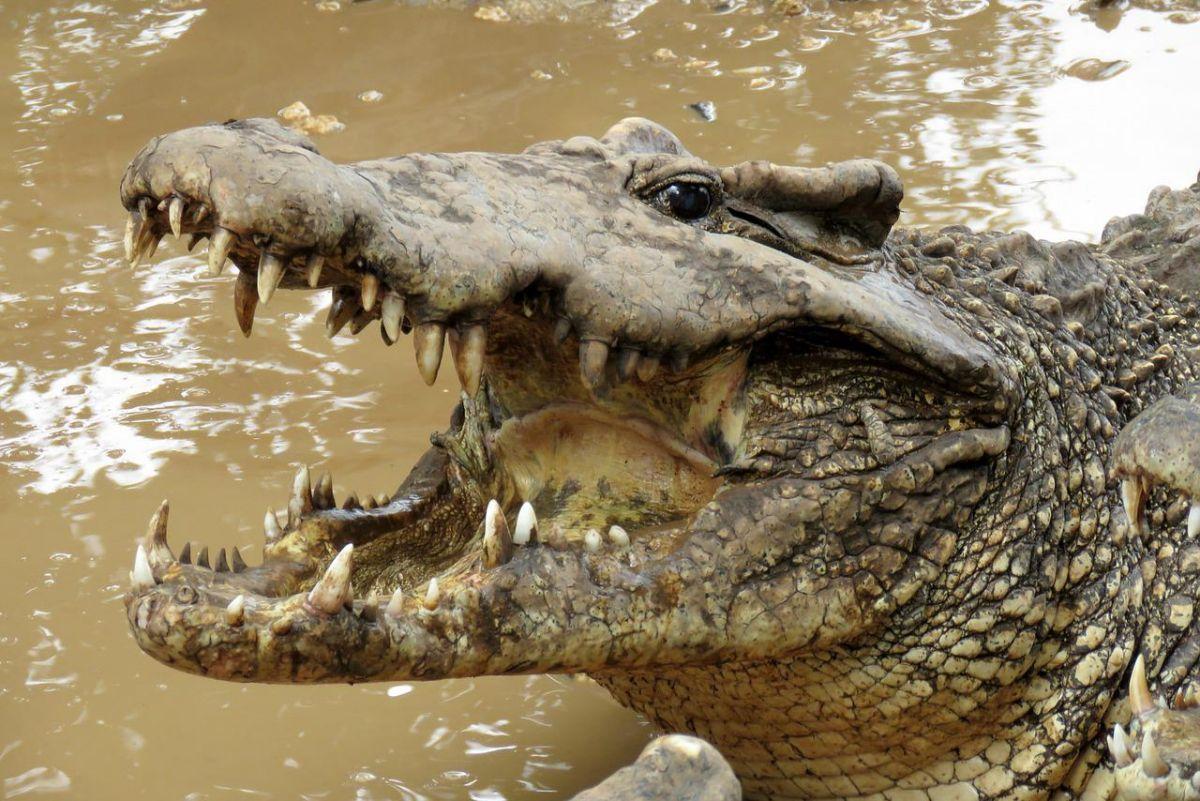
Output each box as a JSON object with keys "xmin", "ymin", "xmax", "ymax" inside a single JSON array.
[{"xmin": 1108, "ymin": 656, "xmax": 1200, "ymax": 801}]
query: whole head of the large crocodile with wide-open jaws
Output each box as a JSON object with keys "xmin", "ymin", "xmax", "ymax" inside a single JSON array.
[{"xmin": 121, "ymin": 119, "xmax": 1022, "ymax": 682}]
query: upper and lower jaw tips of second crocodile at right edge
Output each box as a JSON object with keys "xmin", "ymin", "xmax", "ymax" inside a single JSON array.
[{"xmin": 1108, "ymin": 385, "xmax": 1200, "ymax": 801}]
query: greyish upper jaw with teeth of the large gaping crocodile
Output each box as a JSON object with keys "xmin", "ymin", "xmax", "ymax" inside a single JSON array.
[{"xmin": 121, "ymin": 120, "xmax": 1010, "ymax": 410}]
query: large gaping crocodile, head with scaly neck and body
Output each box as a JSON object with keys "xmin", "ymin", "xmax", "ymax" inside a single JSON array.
[{"xmin": 120, "ymin": 119, "xmax": 1200, "ymax": 801}]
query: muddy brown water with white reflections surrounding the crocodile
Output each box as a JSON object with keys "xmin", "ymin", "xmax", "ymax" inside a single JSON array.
[{"xmin": 0, "ymin": 0, "xmax": 1200, "ymax": 800}]
